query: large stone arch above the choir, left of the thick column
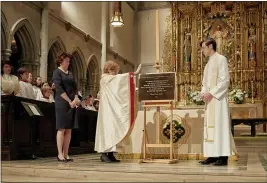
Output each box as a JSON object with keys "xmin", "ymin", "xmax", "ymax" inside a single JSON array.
[{"xmin": 8, "ymin": 18, "xmax": 40, "ymax": 76}]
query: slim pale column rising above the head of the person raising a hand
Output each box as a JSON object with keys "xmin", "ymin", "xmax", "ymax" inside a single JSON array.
[{"xmin": 101, "ymin": 2, "xmax": 108, "ymax": 73}]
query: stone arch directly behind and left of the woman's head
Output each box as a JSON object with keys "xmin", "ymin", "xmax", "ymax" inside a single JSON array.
[{"xmin": 47, "ymin": 36, "xmax": 66, "ymax": 81}]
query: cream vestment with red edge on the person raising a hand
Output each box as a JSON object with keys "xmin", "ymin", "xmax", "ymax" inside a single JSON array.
[{"xmin": 95, "ymin": 73, "xmax": 135, "ymax": 153}]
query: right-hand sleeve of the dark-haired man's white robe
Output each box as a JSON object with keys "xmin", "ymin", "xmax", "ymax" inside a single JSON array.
[{"xmin": 210, "ymin": 57, "xmax": 229, "ymax": 100}]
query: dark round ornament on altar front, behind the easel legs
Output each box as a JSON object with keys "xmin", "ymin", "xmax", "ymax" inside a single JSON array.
[{"xmin": 163, "ymin": 120, "xmax": 185, "ymax": 143}]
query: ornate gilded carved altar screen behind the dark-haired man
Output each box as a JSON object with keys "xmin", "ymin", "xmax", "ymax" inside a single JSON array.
[{"xmin": 164, "ymin": 2, "xmax": 267, "ymax": 107}]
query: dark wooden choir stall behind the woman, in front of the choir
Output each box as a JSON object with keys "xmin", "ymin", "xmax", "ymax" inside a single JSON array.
[{"xmin": 1, "ymin": 95, "xmax": 97, "ymax": 160}]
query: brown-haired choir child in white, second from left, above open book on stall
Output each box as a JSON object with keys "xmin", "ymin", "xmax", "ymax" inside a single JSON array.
[{"xmin": 18, "ymin": 68, "xmax": 36, "ymax": 100}]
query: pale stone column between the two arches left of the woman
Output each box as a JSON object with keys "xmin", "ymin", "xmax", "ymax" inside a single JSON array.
[{"xmin": 40, "ymin": 2, "xmax": 49, "ymax": 81}]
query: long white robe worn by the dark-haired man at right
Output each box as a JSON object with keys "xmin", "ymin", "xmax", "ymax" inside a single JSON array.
[{"xmin": 201, "ymin": 52, "xmax": 235, "ymax": 157}]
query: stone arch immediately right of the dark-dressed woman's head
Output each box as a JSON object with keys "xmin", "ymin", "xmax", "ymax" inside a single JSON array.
[{"xmin": 70, "ymin": 47, "xmax": 86, "ymax": 94}]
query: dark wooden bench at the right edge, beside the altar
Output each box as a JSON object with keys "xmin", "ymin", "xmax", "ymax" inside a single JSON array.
[{"xmin": 231, "ymin": 118, "xmax": 267, "ymax": 137}]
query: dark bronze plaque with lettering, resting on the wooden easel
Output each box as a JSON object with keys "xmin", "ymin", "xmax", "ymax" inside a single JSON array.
[{"xmin": 138, "ymin": 72, "xmax": 175, "ymax": 101}]
